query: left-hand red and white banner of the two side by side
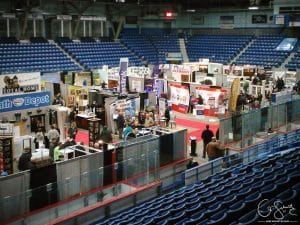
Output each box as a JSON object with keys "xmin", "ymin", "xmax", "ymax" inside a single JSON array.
[{"xmin": 170, "ymin": 83, "xmax": 190, "ymax": 113}]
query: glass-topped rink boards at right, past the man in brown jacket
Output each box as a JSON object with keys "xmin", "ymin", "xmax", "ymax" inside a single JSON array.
[{"xmin": 220, "ymin": 96, "xmax": 300, "ymax": 150}]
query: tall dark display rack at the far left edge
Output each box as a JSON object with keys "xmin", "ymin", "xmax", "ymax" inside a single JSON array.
[{"xmin": 0, "ymin": 137, "xmax": 14, "ymax": 174}]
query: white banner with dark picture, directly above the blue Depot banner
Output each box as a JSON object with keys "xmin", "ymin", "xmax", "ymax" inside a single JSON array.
[{"xmin": 0, "ymin": 73, "xmax": 41, "ymax": 95}]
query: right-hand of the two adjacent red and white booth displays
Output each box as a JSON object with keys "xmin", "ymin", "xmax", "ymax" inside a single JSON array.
[{"xmin": 194, "ymin": 87, "xmax": 228, "ymax": 117}]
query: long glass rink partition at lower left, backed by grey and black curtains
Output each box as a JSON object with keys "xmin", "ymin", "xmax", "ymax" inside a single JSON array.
[{"xmin": 0, "ymin": 135, "xmax": 159, "ymax": 224}]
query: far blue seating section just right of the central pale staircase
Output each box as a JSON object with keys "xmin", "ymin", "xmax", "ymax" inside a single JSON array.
[{"xmin": 186, "ymin": 35, "xmax": 251, "ymax": 64}]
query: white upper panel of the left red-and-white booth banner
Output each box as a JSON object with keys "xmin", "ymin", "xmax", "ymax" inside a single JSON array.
[{"xmin": 170, "ymin": 84, "xmax": 190, "ymax": 106}]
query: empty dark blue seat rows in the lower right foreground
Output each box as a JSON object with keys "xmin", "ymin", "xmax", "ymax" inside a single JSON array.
[{"xmin": 93, "ymin": 148, "xmax": 300, "ymax": 225}]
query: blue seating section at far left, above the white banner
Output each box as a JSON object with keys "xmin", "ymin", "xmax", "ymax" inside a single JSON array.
[{"xmin": 0, "ymin": 43, "xmax": 80, "ymax": 73}]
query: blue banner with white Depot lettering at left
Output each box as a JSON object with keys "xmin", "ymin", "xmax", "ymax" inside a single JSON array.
[{"xmin": 0, "ymin": 91, "xmax": 50, "ymax": 113}]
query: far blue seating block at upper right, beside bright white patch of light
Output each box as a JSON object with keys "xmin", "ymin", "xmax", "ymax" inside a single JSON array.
[{"xmin": 236, "ymin": 36, "xmax": 290, "ymax": 68}]
